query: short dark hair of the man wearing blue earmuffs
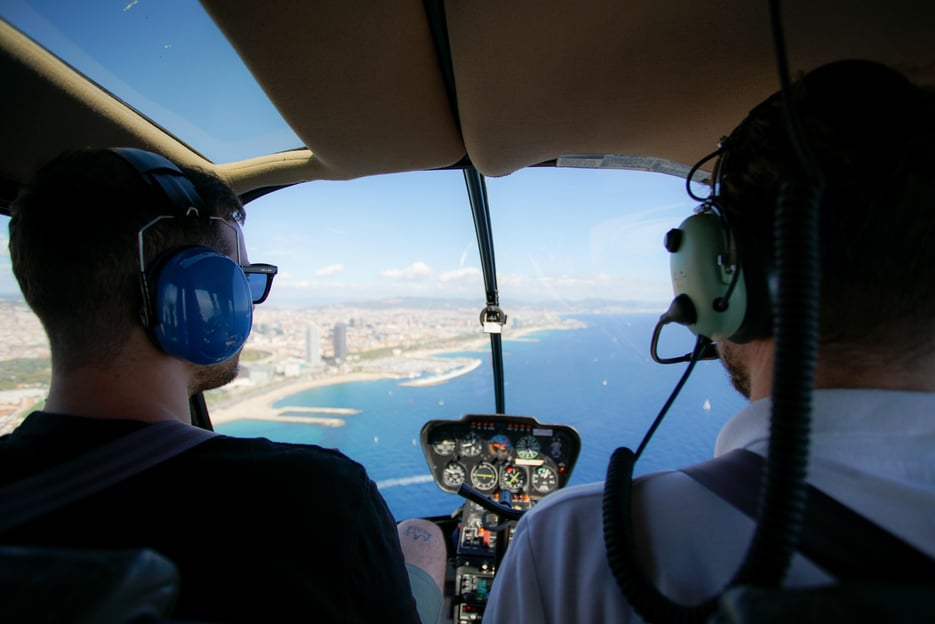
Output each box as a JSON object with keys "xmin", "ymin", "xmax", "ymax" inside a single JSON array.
[{"xmin": 10, "ymin": 149, "xmax": 244, "ymax": 370}]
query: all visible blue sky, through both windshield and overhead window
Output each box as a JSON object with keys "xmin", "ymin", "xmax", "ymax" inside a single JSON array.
[{"xmin": 0, "ymin": 0, "xmax": 694, "ymax": 305}]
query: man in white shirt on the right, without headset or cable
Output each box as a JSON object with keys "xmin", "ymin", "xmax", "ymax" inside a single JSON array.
[{"xmin": 484, "ymin": 61, "xmax": 935, "ymax": 624}]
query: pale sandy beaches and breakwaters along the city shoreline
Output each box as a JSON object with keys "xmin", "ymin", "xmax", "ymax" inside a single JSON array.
[{"xmin": 209, "ymin": 323, "xmax": 585, "ymax": 427}]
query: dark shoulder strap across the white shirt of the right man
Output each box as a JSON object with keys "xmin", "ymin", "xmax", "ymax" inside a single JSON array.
[{"xmin": 681, "ymin": 449, "xmax": 935, "ymax": 582}]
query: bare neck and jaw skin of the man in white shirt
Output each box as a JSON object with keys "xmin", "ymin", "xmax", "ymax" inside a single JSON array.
[{"xmin": 731, "ymin": 338, "xmax": 935, "ymax": 401}]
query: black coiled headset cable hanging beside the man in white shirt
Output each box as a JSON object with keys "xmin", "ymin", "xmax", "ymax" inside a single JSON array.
[{"xmin": 603, "ymin": 0, "xmax": 824, "ymax": 622}]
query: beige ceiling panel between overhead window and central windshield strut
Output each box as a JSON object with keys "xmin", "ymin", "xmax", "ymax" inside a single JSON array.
[{"xmin": 203, "ymin": 0, "xmax": 464, "ymax": 177}]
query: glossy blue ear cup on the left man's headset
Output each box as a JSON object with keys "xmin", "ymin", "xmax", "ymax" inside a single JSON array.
[{"xmin": 148, "ymin": 247, "xmax": 253, "ymax": 365}]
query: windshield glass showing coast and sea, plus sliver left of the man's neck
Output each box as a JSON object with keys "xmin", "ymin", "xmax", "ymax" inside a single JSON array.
[{"xmin": 0, "ymin": 168, "xmax": 743, "ymax": 518}]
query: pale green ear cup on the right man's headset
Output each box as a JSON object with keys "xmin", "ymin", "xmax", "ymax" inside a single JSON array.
[{"xmin": 666, "ymin": 211, "xmax": 747, "ymax": 341}]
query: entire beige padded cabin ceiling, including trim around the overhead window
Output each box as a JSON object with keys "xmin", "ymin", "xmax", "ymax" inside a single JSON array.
[{"xmin": 0, "ymin": 0, "xmax": 935, "ymax": 199}]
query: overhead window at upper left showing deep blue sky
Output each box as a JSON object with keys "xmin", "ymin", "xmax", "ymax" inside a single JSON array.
[{"xmin": 0, "ymin": 0, "xmax": 302, "ymax": 162}]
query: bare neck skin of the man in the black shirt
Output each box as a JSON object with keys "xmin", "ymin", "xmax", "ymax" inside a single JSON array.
[{"xmin": 44, "ymin": 329, "xmax": 192, "ymax": 424}]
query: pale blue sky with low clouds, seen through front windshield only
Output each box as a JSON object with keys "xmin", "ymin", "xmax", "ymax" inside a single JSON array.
[{"xmin": 244, "ymin": 168, "xmax": 694, "ymax": 302}]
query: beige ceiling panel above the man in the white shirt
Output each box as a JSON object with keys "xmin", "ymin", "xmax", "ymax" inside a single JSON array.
[{"xmin": 446, "ymin": 0, "xmax": 935, "ymax": 175}]
